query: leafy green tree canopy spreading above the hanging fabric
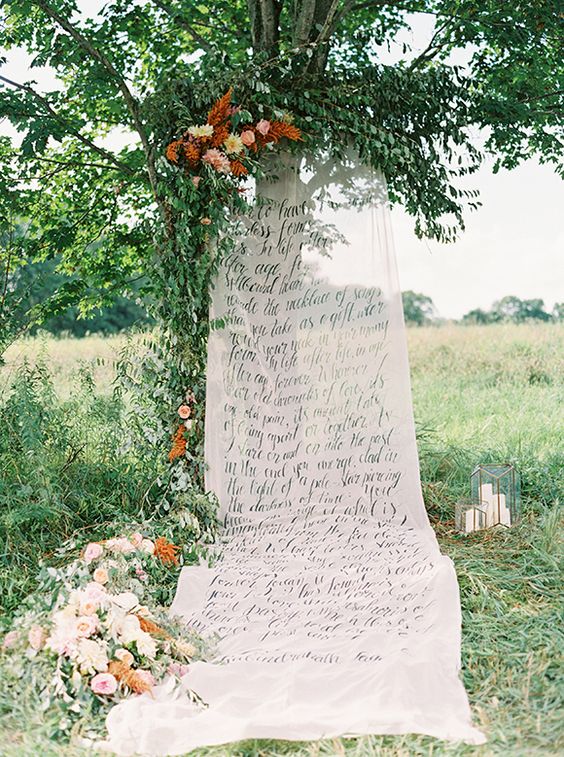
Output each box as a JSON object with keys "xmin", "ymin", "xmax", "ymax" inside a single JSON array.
[{"xmin": 0, "ymin": 0, "xmax": 563, "ymax": 346}]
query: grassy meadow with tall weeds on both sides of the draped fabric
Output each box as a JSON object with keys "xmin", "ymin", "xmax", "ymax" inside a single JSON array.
[{"xmin": 0, "ymin": 324, "xmax": 564, "ymax": 757}]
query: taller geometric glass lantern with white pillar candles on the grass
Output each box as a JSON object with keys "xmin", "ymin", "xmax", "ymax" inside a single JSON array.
[{"xmin": 471, "ymin": 464, "xmax": 521, "ymax": 528}]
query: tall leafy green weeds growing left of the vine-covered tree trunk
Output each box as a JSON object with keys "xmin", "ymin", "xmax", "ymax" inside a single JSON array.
[{"xmin": 0, "ymin": 361, "xmax": 215, "ymax": 613}]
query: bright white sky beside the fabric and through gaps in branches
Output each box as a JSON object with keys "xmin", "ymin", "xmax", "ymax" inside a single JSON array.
[{"xmin": 0, "ymin": 9, "xmax": 564, "ymax": 318}]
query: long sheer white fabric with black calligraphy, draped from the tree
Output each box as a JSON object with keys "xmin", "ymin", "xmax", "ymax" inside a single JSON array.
[{"xmin": 103, "ymin": 152, "xmax": 484, "ymax": 755}]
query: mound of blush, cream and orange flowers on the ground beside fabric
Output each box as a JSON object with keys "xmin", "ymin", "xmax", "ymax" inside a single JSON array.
[{"xmin": 2, "ymin": 532, "xmax": 207, "ymax": 733}]
